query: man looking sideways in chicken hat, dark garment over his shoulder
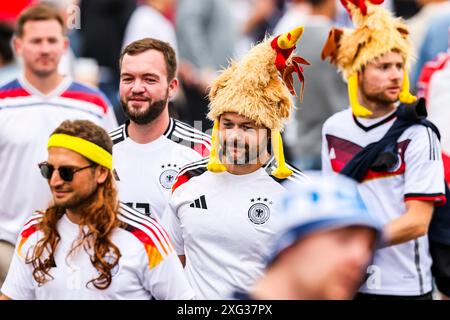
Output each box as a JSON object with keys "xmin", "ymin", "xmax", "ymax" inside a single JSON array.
[{"xmin": 322, "ymin": 1, "xmax": 446, "ymax": 299}]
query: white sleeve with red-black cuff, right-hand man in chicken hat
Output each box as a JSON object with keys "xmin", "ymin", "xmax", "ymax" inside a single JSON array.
[{"xmin": 404, "ymin": 125, "xmax": 445, "ymax": 203}]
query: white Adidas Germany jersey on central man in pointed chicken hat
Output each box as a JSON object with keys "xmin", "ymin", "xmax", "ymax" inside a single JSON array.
[{"xmin": 162, "ymin": 159, "xmax": 304, "ymax": 299}]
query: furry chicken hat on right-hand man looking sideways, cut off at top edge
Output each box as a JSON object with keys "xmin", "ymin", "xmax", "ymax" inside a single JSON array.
[{"xmin": 322, "ymin": 0, "xmax": 416, "ymax": 117}]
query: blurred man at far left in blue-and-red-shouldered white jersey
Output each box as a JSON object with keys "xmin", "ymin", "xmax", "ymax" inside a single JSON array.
[{"xmin": 0, "ymin": 4, "xmax": 117, "ymax": 285}]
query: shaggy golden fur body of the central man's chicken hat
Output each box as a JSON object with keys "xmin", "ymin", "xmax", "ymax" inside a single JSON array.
[{"xmin": 208, "ymin": 39, "xmax": 294, "ymax": 130}]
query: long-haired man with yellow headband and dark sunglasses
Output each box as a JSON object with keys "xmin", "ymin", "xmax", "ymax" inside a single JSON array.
[{"xmin": 1, "ymin": 120, "xmax": 193, "ymax": 300}]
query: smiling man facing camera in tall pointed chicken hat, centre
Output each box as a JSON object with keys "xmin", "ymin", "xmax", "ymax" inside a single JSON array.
[{"xmin": 163, "ymin": 27, "xmax": 310, "ymax": 299}]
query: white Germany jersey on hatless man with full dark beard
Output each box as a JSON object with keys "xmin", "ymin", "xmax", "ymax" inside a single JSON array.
[{"xmin": 110, "ymin": 119, "xmax": 211, "ymax": 218}]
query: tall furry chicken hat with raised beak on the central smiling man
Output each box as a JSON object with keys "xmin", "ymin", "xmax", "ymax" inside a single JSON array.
[{"xmin": 208, "ymin": 27, "xmax": 309, "ymax": 179}]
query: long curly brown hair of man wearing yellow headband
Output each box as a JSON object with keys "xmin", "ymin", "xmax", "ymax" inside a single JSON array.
[{"xmin": 27, "ymin": 120, "xmax": 121, "ymax": 289}]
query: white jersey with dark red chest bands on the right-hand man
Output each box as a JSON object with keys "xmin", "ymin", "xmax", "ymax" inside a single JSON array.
[{"xmin": 322, "ymin": 109, "xmax": 445, "ymax": 296}]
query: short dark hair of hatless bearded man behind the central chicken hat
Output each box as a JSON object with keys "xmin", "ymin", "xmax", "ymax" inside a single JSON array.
[{"xmin": 119, "ymin": 38, "xmax": 177, "ymax": 81}]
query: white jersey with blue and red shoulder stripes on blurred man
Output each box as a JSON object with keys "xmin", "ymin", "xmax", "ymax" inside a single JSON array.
[{"xmin": 0, "ymin": 78, "xmax": 117, "ymax": 243}]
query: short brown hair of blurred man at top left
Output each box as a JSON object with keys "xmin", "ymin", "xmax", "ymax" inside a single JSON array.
[{"xmin": 16, "ymin": 3, "xmax": 66, "ymax": 38}]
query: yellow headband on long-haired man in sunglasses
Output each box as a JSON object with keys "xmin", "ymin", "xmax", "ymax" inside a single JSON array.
[{"xmin": 47, "ymin": 133, "xmax": 112, "ymax": 170}]
